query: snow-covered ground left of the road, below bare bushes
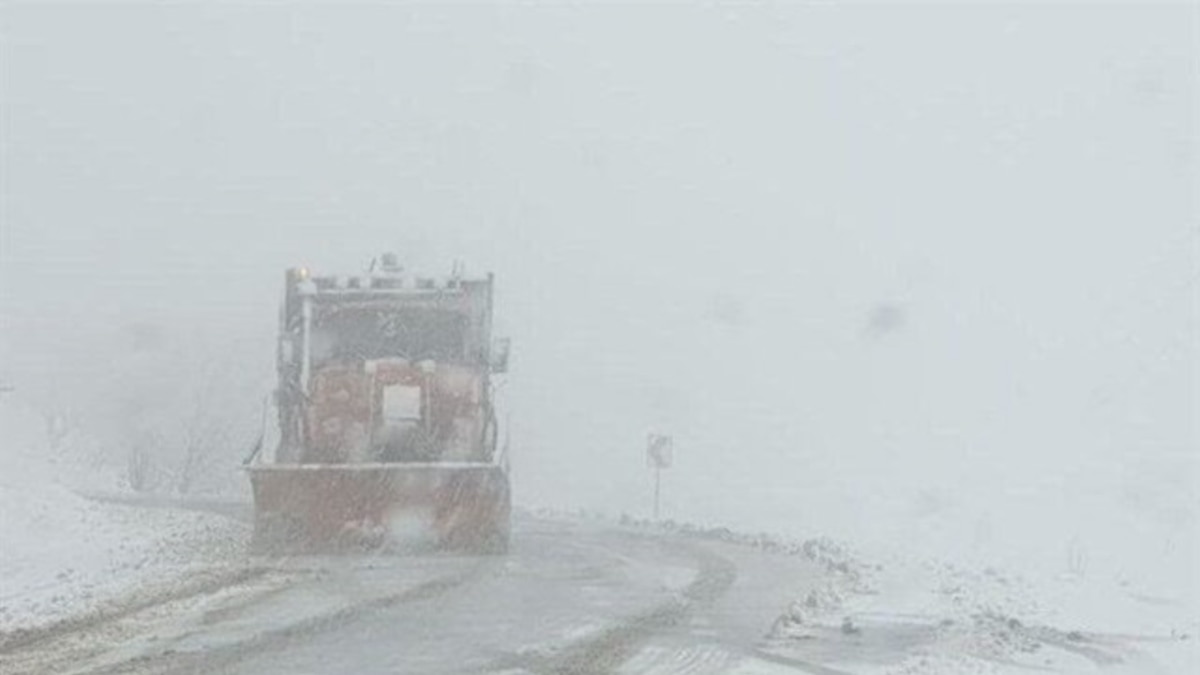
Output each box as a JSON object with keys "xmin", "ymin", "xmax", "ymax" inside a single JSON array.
[{"xmin": 0, "ymin": 399, "xmax": 246, "ymax": 634}]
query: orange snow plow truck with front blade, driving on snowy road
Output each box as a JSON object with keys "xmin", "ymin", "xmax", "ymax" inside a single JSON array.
[{"xmin": 246, "ymin": 255, "xmax": 511, "ymax": 552}]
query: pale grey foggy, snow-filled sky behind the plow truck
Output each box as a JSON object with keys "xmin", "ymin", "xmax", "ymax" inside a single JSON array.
[{"xmin": 0, "ymin": 2, "xmax": 1200, "ymax": 593}]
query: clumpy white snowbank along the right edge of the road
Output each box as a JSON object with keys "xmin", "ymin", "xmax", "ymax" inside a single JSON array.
[{"xmin": 773, "ymin": 538, "xmax": 1200, "ymax": 675}]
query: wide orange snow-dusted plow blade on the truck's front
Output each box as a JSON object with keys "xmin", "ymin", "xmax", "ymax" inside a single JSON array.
[{"xmin": 247, "ymin": 462, "xmax": 511, "ymax": 554}]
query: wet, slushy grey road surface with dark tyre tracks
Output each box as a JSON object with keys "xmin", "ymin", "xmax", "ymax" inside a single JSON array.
[{"xmin": 0, "ymin": 518, "xmax": 826, "ymax": 675}]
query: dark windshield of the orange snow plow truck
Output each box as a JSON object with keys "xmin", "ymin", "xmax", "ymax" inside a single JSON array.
[{"xmin": 311, "ymin": 307, "xmax": 467, "ymax": 364}]
